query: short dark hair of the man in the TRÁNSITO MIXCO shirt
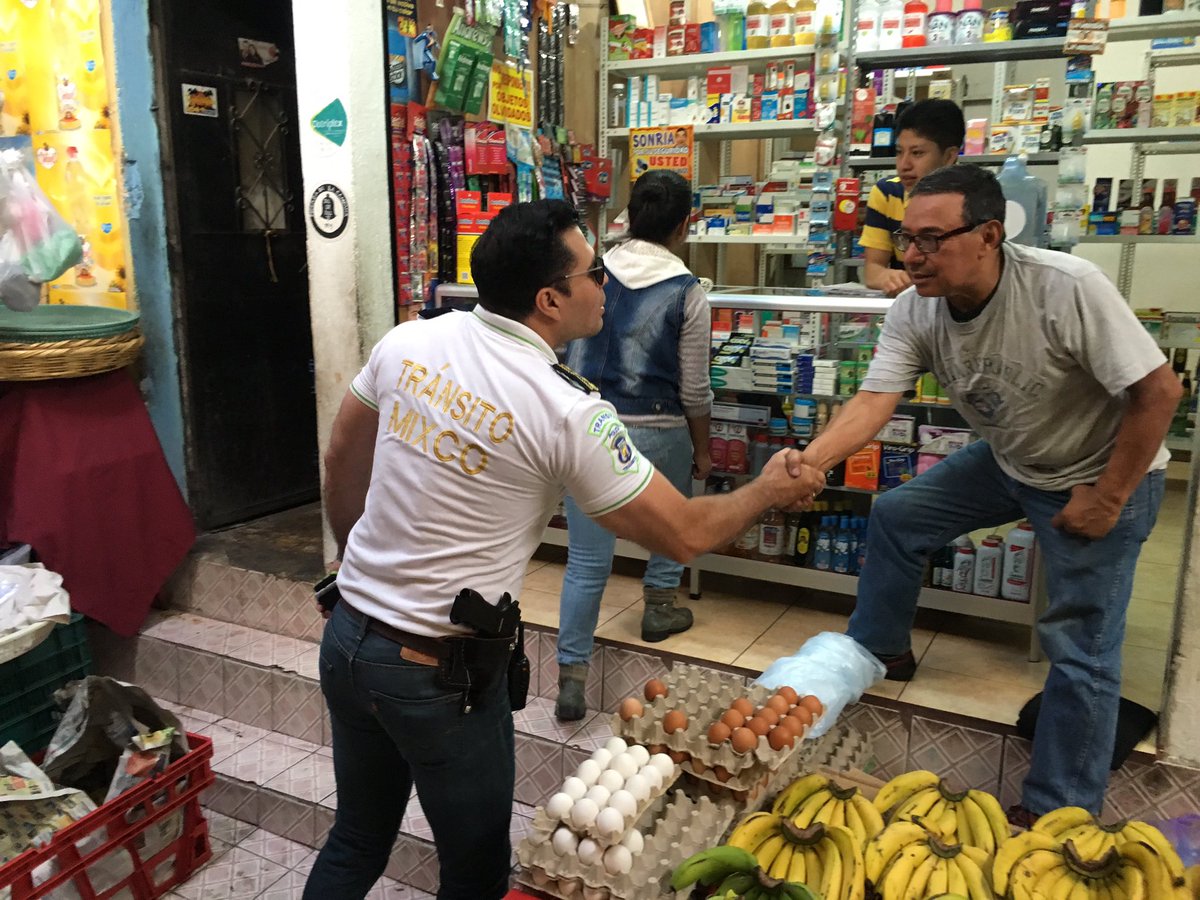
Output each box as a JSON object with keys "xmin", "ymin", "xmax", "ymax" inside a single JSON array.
[{"xmin": 470, "ymin": 200, "xmax": 580, "ymax": 322}]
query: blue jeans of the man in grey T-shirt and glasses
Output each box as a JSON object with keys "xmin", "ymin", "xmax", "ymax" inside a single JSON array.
[{"xmin": 847, "ymin": 440, "xmax": 1164, "ymax": 814}]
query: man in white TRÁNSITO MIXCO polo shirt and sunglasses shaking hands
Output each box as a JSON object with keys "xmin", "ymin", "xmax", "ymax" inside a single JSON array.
[{"xmin": 305, "ymin": 200, "xmax": 824, "ymax": 900}]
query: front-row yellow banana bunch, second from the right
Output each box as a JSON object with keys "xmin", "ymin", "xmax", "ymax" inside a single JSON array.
[{"xmin": 863, "ymin": 821, "xmax": 994, "ymax": 900}]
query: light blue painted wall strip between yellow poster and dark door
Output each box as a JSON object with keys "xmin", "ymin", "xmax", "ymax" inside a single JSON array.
[{"xmin": 110, "ymin": 0, "xmax": 187, "ymax": 497}]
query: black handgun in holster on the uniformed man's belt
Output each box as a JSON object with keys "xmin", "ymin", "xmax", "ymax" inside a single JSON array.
[{"xmin": 438, "ymin": 588, "xmax": 529, "ymax": 713}]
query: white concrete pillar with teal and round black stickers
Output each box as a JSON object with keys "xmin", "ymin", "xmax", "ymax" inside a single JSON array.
[{"xmin": 292, "ymin": 0, "xmax": 395, "ymax": 559}]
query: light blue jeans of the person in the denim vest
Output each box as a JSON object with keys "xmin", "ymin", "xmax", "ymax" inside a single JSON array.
[{"xmin": 558, "ymin": 426, "xmax": 692, "ymax": 666}]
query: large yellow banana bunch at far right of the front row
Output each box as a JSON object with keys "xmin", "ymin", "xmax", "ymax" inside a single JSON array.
[{"xmin": 992, "ymin": 825, "xmax": 1192, "ymax": 900}]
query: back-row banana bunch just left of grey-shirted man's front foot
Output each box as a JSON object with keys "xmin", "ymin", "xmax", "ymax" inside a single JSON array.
[{"xmin": 875, "ymin": 772, "xmax": 1012, "ymax": 856}]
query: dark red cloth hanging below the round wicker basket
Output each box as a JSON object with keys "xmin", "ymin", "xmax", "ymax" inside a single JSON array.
[{"xmin": 0, "ymin": 371, "xmax": 196, "ymax": 636}]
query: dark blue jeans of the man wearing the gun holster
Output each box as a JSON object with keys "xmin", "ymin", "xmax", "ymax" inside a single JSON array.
[{"xmin": 304, "ymin": 602, "xmax": 516, "ymax": 900}]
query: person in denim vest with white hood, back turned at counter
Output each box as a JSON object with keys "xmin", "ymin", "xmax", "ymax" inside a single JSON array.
[{"xmin": 554, "ymin": 172, "xmax": 713, "ymax": 721}]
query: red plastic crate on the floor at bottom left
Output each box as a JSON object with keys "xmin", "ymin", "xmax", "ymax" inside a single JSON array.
[{"xmin": 0, "ymin": 734, "xmax": 214, "ymax": 900}]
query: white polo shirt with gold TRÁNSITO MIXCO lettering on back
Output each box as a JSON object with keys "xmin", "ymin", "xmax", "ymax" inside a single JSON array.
[{"xmin": 337, "ymin": 307, "xmax": 654, "ymax": 637}]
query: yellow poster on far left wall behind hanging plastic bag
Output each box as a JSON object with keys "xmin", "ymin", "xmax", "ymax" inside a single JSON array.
[{"xmin": 0, "ymin": 0, "xmax": 128, "ymax": 308}]
